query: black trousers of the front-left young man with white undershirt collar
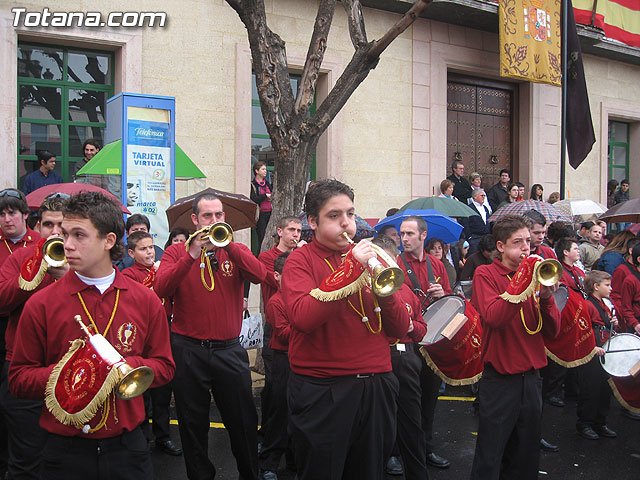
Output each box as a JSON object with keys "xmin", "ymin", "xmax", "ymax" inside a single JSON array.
[{"xmin": 42, "ymin": 427, "xmax": 153, "ymax": 480}]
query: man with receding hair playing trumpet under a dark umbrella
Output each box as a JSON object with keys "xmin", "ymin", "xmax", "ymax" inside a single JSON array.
[{"xmin": 155, "ymin": 194, "xmax": 267, "ymax": 480}]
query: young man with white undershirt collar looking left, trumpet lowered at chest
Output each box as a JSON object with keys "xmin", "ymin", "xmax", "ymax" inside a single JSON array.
[{"xmin": 9, "ymin": 192, "xmax": 174, "ymax": 480}]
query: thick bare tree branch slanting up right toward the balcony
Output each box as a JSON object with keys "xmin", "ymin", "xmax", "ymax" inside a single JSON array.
[{"xmin": 302, "ymin": 0, "xmax": 431, "ymax": 139}]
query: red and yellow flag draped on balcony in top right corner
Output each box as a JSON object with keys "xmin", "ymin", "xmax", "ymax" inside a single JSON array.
[{"xmin": 573, "ymin": 0, "xmax": 640, "ymax": 47}]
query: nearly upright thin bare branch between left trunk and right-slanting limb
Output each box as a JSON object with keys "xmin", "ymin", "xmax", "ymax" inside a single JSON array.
[{"xmin": 295, "ymin": 0, "xmax": 336, "ymax": 115}]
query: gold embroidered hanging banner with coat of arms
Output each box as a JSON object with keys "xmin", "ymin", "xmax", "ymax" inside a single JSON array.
[{"xmin": 499, "ymin": 0, "xmax": 562, "ymax": 86}]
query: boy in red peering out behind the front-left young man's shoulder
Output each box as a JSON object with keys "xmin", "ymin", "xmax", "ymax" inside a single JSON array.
[{"xmin": 122, "ymin": 230, "xmax": 182, "ymax": 456}]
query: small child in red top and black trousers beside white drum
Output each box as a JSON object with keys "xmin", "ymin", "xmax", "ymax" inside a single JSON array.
[{"xmin": 576, "ymin": 270, "xmax": 618, "ymax": 440}]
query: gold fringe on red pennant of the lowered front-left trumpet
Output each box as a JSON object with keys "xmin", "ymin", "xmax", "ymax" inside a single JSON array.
[{"xmin": 45, "ymin": 338, "xmax": 121, "ymax": 429}]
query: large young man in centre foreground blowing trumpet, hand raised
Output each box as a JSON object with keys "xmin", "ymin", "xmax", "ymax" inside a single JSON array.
[{"xmin": 282, "ymin": 179, "xmax": 411, "ymax": 480}]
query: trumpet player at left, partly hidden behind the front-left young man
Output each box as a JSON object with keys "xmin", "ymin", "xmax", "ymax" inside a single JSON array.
[{"xmin": 0, "ymin": 195, "xmax": 69, "ymax": 479}]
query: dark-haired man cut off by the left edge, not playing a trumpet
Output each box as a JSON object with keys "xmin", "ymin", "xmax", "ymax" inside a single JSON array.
[{"xmin": 0, "ymin": 188, "xmax": 40, "ymax": 475}]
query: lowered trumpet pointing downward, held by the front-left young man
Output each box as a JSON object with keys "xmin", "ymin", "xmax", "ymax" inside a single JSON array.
[{"xmin": 74, "ymin": 315, "xmax": 155, "ymax": 400}]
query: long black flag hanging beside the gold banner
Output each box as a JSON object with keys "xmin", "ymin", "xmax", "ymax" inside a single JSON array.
[{"xmin": 562, "ymin": 0, "xmax": 596, "ymax": 168}]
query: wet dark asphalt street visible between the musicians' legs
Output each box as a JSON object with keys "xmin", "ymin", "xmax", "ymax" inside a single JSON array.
[{"xmin": 153, "ymin": 387, "xmax": 640, "ymax": 480}]
